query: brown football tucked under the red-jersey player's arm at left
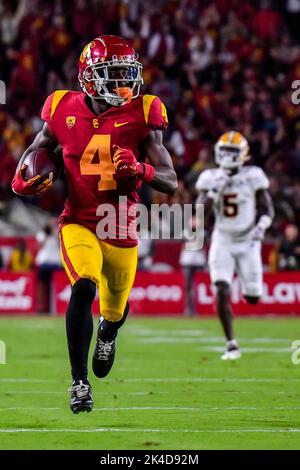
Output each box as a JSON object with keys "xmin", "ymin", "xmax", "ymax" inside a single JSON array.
[{"xmin": 24, "ymin": 148, "xmax": 60, "ymax": 182}]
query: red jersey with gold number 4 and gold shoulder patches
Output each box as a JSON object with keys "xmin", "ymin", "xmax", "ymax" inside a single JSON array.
[{"xmin": 41, "ymin": 90, "xmax": 168, "ymax": 247}]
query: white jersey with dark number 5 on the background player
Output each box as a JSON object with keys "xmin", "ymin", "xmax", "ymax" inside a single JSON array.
[{"xmin": 196, "ymin": 166, "xmax": 269, "ymax": 239}]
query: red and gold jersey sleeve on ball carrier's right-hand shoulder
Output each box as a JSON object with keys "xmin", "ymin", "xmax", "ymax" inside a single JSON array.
[{"xmin": 143, "ymin": 95, "xmax": 168, "ymax": 130}]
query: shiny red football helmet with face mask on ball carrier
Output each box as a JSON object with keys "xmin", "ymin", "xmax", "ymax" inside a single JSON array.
[{"xmin": 78, "ymin": 36, "xmax": 143, "ymax": 106}]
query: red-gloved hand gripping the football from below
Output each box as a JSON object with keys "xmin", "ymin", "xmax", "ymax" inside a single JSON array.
[{"xmin": 11, "ymin": 164, "xmax": 53, "ymax": 196}]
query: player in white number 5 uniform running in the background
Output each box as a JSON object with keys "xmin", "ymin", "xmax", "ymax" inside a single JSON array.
[{"xmin": 196, "ymin": 131, "xmax": 274, "ymax": 360}]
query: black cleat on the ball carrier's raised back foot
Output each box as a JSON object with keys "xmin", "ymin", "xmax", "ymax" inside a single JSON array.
[{"xmin": 93, "ymin": 321, "xmax": 117, "ymax": 378}]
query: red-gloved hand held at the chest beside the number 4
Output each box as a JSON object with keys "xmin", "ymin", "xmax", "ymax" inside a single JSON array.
[{"xmin": 113, "ymin": 145, "xmax": 155, "ymax": 183}]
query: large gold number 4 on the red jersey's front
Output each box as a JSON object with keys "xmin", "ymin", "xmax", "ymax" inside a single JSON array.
[{"xmin": 80, "ymin": 135, "xmax": 117, "ymax": 191}]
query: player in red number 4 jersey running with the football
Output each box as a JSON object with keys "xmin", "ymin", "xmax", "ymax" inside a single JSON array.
[{"xmin": 12, "ymin": 36, "xmax": 177, "ymax": 413}]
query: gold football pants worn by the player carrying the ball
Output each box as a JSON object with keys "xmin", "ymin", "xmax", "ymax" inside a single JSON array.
[{"xmin": 60, "ymin": 224, "xmax": 137, "ymax": 321}]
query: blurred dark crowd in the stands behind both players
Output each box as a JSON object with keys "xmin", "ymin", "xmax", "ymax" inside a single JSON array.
[{"xmin": 0, "ymin": 0, "xmax": 300, "ymax": 270}]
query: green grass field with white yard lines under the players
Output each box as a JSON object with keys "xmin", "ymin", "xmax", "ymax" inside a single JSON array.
[{"xmin": 0, "ymin": 317, "xmax": 300, "ymax": 450}]
